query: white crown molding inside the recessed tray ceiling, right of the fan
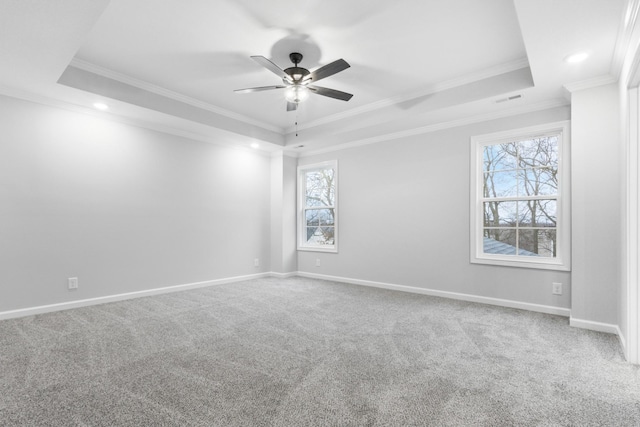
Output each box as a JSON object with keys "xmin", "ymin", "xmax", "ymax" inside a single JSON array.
[{"xmin": 285, "ymin": 57, "xmax": 528, "ymax": 133}]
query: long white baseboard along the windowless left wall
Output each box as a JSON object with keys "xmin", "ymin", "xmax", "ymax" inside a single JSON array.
[{"xmin": 0, "ymin": 273, "xmax": 272, "ymax": 320}]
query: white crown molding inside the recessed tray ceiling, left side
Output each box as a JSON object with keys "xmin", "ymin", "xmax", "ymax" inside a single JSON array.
[{"xmin": 69, "ymin": 58, "xmax": 284, "ymax": 134}]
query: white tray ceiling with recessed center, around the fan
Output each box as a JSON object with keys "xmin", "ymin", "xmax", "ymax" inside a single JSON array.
[{"xmin": 0, "ymin": 0, "xmax": 628, "ymax": 151}]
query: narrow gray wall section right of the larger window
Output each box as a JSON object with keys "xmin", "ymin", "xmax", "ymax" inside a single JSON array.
[{"xmin": 571, "ymin": 84, "xmax": 624, "ymax": 325}]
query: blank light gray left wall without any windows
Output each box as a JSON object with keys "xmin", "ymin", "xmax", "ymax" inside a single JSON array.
[{"xmin": 0, "ymin": 97, "xmax": 270, "ymax": 312}]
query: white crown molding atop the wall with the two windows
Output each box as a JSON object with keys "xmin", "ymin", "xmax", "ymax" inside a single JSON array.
[{"xmin": 293, "ymin": 99, "xmax": 569, "ymax": 157}]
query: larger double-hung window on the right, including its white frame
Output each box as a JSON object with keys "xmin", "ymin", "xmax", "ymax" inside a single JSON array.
[{"xmin": 471, "ymin": 122, "xmax": 570, "ymax": 270}]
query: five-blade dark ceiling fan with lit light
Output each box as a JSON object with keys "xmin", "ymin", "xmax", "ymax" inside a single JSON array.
[{"xmin": 234, "ymin": 52, "xmax": 353, "ymax": 111}]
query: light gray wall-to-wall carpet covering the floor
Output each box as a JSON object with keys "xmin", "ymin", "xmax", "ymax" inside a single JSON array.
[{"xmin": 0, "ymin": 278, "xmax": 640, "ymax": 426}]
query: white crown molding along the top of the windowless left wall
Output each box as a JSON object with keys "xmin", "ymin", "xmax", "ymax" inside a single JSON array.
[{"xmin": 0, "ymin": 85, "xmax": 269, "ymax": 155}]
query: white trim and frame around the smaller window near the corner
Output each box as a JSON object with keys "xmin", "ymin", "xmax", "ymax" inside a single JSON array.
[{"xmin": 297, "ymin": 160, "xmax": 339, "ymax": 253}]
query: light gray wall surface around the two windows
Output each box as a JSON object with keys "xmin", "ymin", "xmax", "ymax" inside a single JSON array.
[{"xmin": 298, "ymin": 107, "xmax": 571, "ymax": 308}]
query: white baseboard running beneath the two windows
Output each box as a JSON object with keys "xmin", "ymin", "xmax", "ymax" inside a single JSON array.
[{"xmin": 297, "ymin": 271, "xmax": 571, "ymax": 317}]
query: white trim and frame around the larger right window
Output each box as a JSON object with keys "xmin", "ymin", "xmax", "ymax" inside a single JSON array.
[{"xmin": 469, "ymin": 121, "xmax": 571, "ymax": 271}]
